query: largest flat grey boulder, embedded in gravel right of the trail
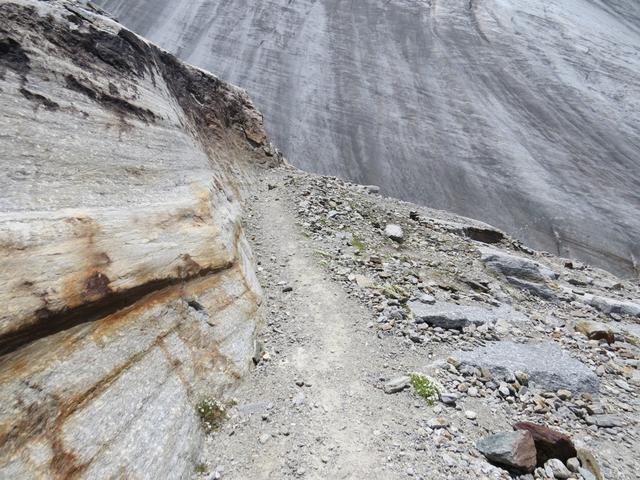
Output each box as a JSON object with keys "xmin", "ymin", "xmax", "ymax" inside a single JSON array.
[{"xmin": 453, "ymin": 341, "xmax": 599, "ymax": 393}]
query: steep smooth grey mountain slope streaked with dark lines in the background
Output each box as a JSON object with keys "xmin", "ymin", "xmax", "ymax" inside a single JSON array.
[{"xmin": 98, "ymin": 0, "xmax": 640, "ymax": 275}]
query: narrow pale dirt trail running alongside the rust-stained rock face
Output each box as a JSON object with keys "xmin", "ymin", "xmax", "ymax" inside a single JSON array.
[{"xmin": 205, "ymin": 173, "xmax": 436, "ymax": 479}]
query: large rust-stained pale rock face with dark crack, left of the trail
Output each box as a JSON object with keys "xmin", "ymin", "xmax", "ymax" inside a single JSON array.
[{"xmin": 0, "ymin": 0, "xmax": 268, "ymax": 478}]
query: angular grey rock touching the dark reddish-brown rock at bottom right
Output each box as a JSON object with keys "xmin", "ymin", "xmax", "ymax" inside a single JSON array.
[{"xmin": 476, "ymin": 430, "xmax": 536, "ymax": 473}]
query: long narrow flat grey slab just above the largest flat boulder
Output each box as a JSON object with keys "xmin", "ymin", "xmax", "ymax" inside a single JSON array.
[{"xmin": 407, "ymin": 301, "xmax": 526, "ymax": 329}]
